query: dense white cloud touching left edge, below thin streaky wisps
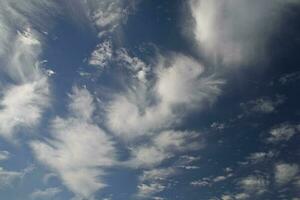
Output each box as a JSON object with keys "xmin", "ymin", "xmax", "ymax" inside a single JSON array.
[{"xmin": 0, "ymin": 78, "xmax": 49, "ymax": 139}]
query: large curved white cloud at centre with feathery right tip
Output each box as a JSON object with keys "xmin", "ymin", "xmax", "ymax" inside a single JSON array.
[{"xmin": 106, "ymin": 54, "xmax": 223, "ymax": 140}]
